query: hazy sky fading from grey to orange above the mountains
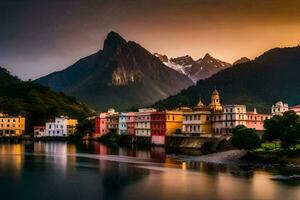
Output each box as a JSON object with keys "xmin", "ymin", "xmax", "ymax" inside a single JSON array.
[{"xmin": 0, "ymin": 0, "xmax": 300, "ymax": 80}]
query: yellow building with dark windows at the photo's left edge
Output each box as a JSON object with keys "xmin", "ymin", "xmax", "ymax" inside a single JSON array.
[{"xmin": 0, "ymin": 113, "xmax": 25, "ymax": 136}]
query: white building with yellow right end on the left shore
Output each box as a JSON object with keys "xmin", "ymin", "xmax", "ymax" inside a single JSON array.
[{"xmin": 45, "ymin": 116, "xmax": 78, "ymax": 137}]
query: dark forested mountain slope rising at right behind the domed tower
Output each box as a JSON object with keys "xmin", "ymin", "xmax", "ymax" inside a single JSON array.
[{"xmin": 154, "ymin": 46, "xmax": 300, "ymax": 112}]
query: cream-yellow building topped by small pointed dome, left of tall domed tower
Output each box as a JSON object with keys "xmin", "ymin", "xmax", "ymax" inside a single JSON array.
[{"xmin": 182, "ymin": 99, "xmax": 212, "ymax": 136}]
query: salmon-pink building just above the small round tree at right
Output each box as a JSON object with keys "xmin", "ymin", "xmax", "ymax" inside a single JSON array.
[{"xmin": 246, "ymin": 108, "xmax": 271, "ymax": 131}]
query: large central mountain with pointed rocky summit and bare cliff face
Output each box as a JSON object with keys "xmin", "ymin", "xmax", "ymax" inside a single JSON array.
[{"xmin": 35, "ymin": 32, "xmax": 193, "ymax": 111}]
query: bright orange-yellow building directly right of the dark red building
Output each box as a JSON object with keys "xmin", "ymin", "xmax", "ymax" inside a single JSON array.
[{"xmin": 166, "ymin": 110, "xmax": 182, "ymax": 135}]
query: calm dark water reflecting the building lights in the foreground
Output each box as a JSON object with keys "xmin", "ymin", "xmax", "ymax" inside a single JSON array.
[{"xmin": 0, "ymin": 142, "xmax": 300, "ymax": 200}]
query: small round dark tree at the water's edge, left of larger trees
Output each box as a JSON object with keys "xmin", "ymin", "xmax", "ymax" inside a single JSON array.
[{"xmin": 230, "ymin": 125, "xmax": 260, "ymax": 150}]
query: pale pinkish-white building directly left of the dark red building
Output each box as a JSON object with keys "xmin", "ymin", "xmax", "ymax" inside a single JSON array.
[{"xmin": 134, "ymin": 108, "xmax": 156, "ymax": 137}]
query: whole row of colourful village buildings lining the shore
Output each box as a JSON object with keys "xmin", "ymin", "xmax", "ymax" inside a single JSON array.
[{"xmin": 0, "ymin": 89, "xmax": 300, "ymax": 145}]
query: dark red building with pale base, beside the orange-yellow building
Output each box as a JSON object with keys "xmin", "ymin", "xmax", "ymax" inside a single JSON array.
[{"xmin": 150, "ymin": 112, "xmax": 167, "ymax": 144}]
